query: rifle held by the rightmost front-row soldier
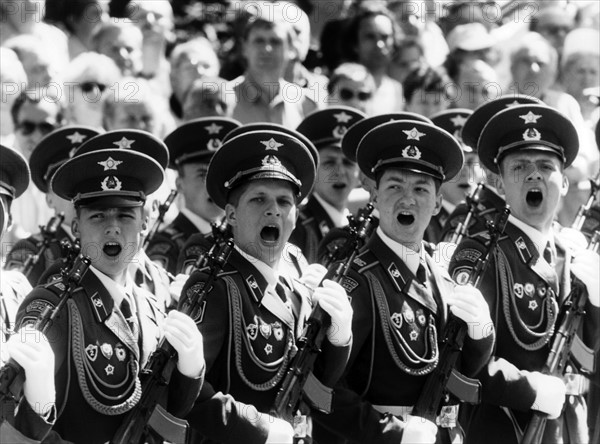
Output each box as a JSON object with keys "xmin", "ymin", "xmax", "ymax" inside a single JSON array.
[{"xmin": 521, "ymin": 225, "xmax": 600, "ymax": 444}]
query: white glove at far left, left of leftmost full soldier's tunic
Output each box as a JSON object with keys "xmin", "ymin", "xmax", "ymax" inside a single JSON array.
[{"xmin": 7, "ymin": 324, "xmax": 56, "ymax": 416}]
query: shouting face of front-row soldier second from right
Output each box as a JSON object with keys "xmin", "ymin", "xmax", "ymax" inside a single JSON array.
[{"xmin": 375, "ymin": 169, "xmax": 442, "ymax": 250}]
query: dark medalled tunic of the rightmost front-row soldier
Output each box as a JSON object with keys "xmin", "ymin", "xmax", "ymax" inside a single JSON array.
[{"xmin": 466, "ymin": 220, "xmax": 600, "ymax": 444}]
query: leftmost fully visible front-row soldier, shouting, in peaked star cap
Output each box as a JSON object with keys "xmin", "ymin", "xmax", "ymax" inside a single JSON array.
[{"xmin": 10, "ymin": 134, "xmax": 205, "ymax": 444}]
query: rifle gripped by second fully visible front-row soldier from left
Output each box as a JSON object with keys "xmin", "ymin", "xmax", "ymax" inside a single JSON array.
[{"xmin": 273, "ymin": 208, "xmax": 374, "ymax": 418}]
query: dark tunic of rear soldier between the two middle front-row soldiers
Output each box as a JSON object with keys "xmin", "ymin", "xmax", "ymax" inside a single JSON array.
[{"xmin": 290, "ymin": 196, "xmax": 335, "ymax": 264}]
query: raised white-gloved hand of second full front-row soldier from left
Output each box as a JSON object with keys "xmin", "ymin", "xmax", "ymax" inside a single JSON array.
[{"xmin": 313, "ymin": 279, "xmax": 352, "ymax": 347}]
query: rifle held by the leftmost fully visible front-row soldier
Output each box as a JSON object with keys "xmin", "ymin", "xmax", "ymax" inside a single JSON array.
[{"xmin": 110, "ymin": 234, "xmax": 233, "ymax": 444}]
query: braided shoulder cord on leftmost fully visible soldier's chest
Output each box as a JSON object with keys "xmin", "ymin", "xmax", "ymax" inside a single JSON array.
[{"xmin": 67, "ymin": 300, "xmax": 142, "ymax": 416}]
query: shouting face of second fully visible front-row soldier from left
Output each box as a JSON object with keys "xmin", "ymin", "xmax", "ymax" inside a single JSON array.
[{"xmin": 225, "ymin": 180, "xmax": 298, "ymax": 267}]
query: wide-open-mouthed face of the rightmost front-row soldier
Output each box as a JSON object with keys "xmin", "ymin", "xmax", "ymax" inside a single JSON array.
[{"xmin": 498, "ymin": 150, "xmax": 569, "ymax": 231}]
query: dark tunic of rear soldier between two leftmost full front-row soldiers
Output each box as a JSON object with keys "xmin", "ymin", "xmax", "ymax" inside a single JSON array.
[{"xmin": 146, "ymin": 213, "xmax": 203, "ymax": 275}]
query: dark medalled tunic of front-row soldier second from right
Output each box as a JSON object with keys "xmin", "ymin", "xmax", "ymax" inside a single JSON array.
[{"xmin": 315, "ymin": 233, "xmax": 493, "ymax": 444}]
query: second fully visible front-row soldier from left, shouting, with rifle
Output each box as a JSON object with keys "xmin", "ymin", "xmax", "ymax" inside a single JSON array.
[{"xmin": 180, "ymin": 130, "xmax": 352, "ymax": 444}]
